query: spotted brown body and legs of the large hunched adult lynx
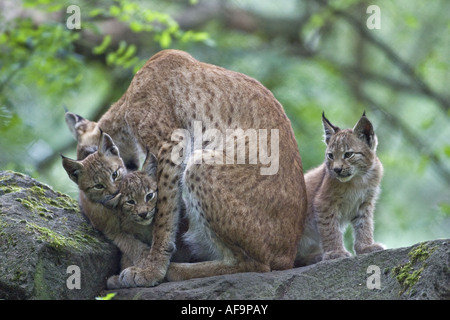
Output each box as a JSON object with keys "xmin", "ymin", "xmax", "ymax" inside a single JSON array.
[{"xmin": 65, "ymin": 50, "xmax": 306, "ymax": 287}]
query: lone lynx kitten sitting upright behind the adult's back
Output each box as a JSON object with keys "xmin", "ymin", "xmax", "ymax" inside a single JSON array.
[{"xmin": 296, "ymin": 113, "xmax": 384, "ymax": 266}]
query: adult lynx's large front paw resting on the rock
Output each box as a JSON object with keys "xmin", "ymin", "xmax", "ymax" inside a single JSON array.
[{"xmin": 119, "ymin": 267, "xmax": 164, "ymax": 288}]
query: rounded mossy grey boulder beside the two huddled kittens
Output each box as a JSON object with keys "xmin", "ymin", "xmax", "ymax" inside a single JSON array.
[{"xmin": 0, "ymin": 171, "xmax": 119, "ymax": 299}]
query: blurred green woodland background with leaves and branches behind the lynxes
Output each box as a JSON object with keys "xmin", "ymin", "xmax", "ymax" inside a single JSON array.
[{"xmin": 0, "ymin": 0, "xmax": 450, "ymax": 248}]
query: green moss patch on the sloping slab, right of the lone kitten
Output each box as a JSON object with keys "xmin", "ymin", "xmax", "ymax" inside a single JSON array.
[{"xmin": 392, "ymin": 243, "xmax": 436, "ymax": 295}]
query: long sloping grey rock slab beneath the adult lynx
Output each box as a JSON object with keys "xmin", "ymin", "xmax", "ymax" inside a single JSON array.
[{"xmin": 103, "ymin": 239, "xmax": 450, "ymax": 300}]
